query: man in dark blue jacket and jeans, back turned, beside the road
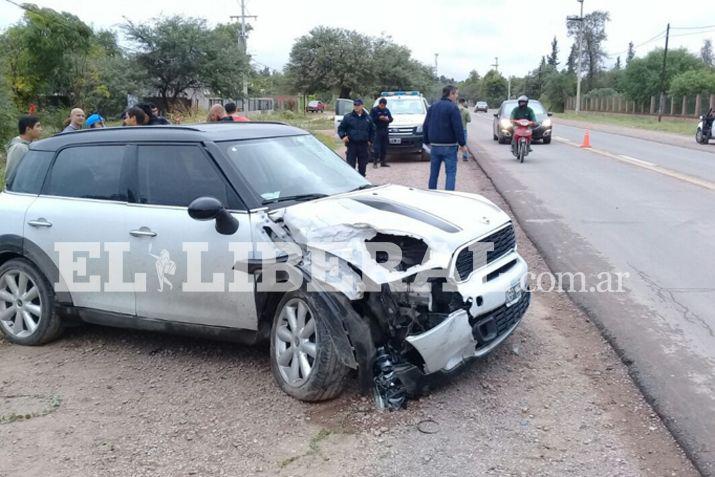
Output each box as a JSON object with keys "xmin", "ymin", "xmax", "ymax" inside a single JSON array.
[{"xmin": 422, "ymin": 85, "xmax": 466, "ymax": 190}]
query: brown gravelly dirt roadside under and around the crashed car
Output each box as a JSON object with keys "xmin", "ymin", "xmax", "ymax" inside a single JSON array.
[{"xmin": 0, "ymin": 149, "xmax": 697, "ymax": 477}]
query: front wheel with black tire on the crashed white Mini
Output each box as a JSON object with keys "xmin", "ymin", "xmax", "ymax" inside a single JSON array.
[{"xmin": 270, "ymin": 290, "xmax": 349, "ymax": 402}]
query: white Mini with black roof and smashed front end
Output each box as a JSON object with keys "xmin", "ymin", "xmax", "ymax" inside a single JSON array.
[{"xmin": 0, "ymin": 122, "xmax": 530, "ymax": 407}]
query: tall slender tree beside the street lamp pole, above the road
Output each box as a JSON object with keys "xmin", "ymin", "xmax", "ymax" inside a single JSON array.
[{"xmin": 566, "ymin": 10, "xmax": 610, "ymax": 89}]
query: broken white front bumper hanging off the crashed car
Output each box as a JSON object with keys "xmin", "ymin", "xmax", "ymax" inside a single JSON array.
[{"xmin": 406, "ymin": 254, "xmax": 531, "ymax": 374}]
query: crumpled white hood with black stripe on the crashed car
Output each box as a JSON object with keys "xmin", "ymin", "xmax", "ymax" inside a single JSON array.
[{"xmin": 269, "ymin": 185, "xmax": 510, "ymax": 283}]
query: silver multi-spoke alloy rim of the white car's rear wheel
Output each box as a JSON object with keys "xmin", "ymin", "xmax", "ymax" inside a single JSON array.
[{"xmin": 0, "ymin": 270, "xmax": 42, "ymax": 338}]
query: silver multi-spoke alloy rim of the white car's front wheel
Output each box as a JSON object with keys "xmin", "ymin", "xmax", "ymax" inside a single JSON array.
[{"xmin": 274, "ymin": 298, "xmax": 318, "ymax": 387}]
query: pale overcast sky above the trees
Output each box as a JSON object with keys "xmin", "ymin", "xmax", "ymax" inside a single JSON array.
[{"xmin": 0, "ymin": 0, "xmax": 715, "ymax": 80}]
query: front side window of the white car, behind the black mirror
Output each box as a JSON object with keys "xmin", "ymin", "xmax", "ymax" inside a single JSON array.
[{"xmin": 137, "ymin": 145, "xmax": 240, "ymax": 209}]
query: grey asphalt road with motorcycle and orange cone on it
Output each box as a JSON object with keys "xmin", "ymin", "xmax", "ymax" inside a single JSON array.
[{"xmin": 469, "ymin": 113, "xmax": 715, "ymax": 475}]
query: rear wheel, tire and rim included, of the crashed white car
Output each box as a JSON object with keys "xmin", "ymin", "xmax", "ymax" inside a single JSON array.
[{"xmin": 0, "ymin": 258, "xmax": 62, "ymax": 346}]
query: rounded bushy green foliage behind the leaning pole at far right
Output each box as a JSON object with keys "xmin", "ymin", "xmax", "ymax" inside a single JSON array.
[{"xmin": 621, "ymin": 48, "xmax": 703, "ymax": 103}]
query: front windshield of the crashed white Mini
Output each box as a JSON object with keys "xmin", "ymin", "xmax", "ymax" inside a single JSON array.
[{"xmin": 222, "ymin": 135, "xmax": 370, "ymax": 203}]
